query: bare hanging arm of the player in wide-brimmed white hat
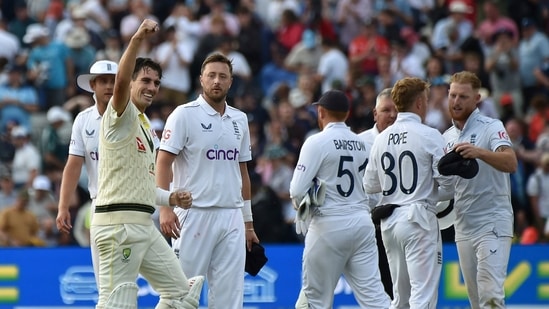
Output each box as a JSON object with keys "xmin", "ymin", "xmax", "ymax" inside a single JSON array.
[{"xmin": 55, "ymin": 155, "xmax": 84, "ymax": 233}]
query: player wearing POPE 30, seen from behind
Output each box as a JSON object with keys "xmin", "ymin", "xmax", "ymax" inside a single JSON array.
[{"xmin": 364, "ymin": 78, "xmax": 452, "ymax": 309}]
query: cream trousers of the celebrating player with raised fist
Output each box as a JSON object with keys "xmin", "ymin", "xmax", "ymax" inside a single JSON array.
[{"xmin": 91, "ymin": 212, "xmax": 189, "ymax": 309}]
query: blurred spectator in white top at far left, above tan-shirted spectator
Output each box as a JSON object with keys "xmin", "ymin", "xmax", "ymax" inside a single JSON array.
[{"xmin": 11, "ymin": 126, "xmax": 42, "ymax": 190}]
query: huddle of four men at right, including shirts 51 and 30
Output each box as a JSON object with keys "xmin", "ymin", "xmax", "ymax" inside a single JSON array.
[{"xmin": 290, "ymin": 72, "xmax": 517, "ymax": 309}]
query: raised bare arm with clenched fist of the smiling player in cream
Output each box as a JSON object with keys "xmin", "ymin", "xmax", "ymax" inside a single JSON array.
[{"xmin": 111, "ymin": 19, "xmax": 158, "ymax": 116}]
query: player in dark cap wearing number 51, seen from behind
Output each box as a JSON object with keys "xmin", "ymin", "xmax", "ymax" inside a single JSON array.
[{"xmin": 290, "ymin": 90, "xmax": 390, "ymax": 309}]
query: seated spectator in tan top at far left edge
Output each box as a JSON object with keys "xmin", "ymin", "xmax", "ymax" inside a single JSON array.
[{"xmin": 0, "ymin": 190, "xmax": 44, "ymax": 247}]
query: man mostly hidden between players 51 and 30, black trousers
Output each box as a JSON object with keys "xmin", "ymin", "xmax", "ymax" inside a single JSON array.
[{"xmin": 358, "ymin": 88, "xmax": 397, "ymax": 298}]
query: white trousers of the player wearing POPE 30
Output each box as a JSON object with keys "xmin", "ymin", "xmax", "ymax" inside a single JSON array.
[{"xmin": 381, "ymin": 205, "xmax": 442, "ymax": 309}]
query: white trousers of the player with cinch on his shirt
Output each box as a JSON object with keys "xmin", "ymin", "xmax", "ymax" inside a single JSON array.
[{"xmin": 172, "ymin": 207, "xmax": 246, "ymax": 309}]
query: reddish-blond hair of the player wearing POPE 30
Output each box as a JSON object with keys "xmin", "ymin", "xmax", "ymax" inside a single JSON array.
[{"xmin": 391, "ymin": 77, "xmax": 430, "ymax": 112}]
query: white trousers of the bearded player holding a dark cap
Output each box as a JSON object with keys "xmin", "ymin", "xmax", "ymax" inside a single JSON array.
[{"xmin": 456, "ymin": 233, "xmax": 512, "ymax": 309}]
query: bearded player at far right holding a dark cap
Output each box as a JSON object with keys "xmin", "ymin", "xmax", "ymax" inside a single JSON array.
[{"xmin": 444, "ymin": 71, "xmax": 517, "ymax": 309}]
